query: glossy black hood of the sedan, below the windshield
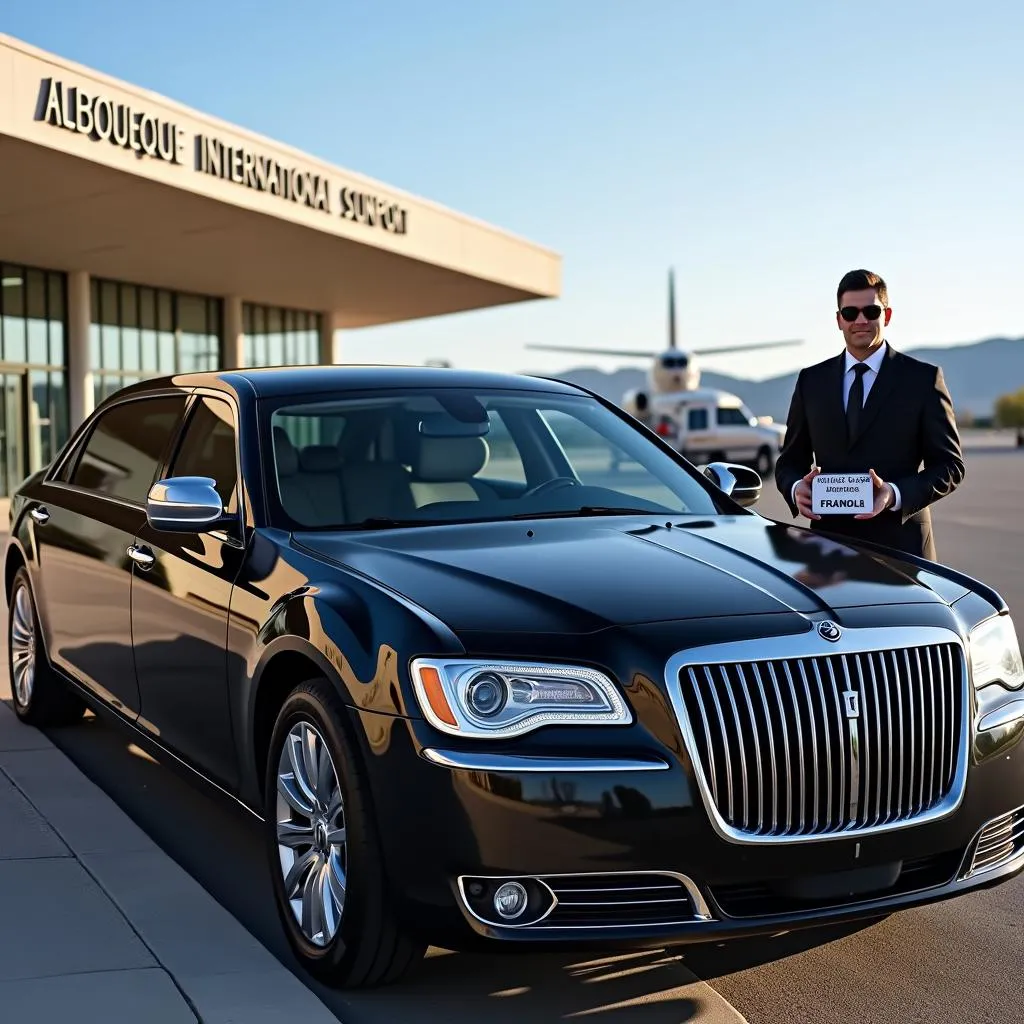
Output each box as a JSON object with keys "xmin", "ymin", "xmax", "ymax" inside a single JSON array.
[{"xmin": 294, "ymin": 515, "xmax": 967, "ymax": 633}]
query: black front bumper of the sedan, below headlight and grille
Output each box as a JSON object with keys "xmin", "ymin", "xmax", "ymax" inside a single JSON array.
[{"xmin": 356, "ymin": 704, "xmax": 1024, "ymax": 950}]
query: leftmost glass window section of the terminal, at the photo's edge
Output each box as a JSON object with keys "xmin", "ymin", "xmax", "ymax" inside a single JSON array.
[{"xmin": 0, "ymin": 262, "xmax": 69, "ymax": 497}]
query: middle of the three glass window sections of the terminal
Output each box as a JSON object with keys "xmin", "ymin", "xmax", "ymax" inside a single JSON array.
[{"xmin": 89, "ymin": 278, "xmax": 223, "ymax": 404}]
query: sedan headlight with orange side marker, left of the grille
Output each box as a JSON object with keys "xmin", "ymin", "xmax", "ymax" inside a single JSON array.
[{"xmin": 412, "ymin": 657, "xmax": 633, "ymax": 739}]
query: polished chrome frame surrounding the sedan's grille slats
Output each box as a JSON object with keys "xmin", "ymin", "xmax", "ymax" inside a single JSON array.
[{"xmin": 665, "ymin": 621, "xmax": 973, "ymax": 847}]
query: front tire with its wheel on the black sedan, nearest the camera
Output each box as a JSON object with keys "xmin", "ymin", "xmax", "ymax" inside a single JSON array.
[{"xmin": 264, "ymin": 678, "xmax": 427, "ymax": 988}]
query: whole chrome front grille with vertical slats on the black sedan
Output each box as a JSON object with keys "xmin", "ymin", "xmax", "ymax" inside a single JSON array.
[{"xmin": 674, "ymin": 630, "xmax": 966, "ymax": 841}]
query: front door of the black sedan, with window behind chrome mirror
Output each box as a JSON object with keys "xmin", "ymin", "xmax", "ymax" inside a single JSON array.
[{"xmin": 131, "ymin": 394, "xmax": 245, "ymax": 790}]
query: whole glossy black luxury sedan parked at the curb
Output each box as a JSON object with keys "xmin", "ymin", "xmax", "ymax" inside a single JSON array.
[{"xmin": 5, "ymin": 367, "xmax": 1024, "ymax": 987}]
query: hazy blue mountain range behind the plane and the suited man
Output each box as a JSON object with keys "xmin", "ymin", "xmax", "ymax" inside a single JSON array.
[{"xmin": 543, "ymin": 338, "xmax": 1024, "ymax": 423}]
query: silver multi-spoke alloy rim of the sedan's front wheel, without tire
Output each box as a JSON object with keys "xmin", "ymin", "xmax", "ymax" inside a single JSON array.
[{"xmin": 275, "ymin": 722, "xmax": 348, "ymax": 947}]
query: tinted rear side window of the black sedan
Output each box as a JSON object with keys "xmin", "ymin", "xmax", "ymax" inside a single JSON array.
[{"xmin": 69, "ymin": 395, "xmax": 185, "ymax": 505}]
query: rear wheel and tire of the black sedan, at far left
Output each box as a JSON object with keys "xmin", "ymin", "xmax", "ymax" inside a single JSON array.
[{"xmin": 7, "ymin": 565, "xmax": 85, "ymax": 729}]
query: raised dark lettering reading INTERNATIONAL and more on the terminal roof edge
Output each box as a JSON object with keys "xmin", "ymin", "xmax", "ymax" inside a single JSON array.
[{"xmin": 36, "ymin": 78, "xmax": 409, "ymax": 234}]
